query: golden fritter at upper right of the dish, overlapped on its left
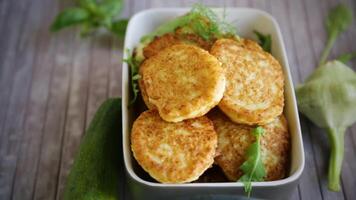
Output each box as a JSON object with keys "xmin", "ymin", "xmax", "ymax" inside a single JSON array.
[{"xmin": 210, "ymin": 39, "xmax": 284, "ymax": 125}]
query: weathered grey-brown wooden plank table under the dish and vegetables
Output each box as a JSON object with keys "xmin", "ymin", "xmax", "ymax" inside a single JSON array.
[{"xmin": 0, "ymin": 0, "xmax": 356, "ymax": 200}]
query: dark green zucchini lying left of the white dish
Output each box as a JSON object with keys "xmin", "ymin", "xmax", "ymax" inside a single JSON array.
[{"xmin": 64, "ymin": 98, "xmax": 123, "ymax": 200}]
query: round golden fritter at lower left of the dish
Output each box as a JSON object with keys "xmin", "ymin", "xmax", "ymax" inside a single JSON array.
[{"xmin": 131, "ymin": 110, "xmax": 217, "ymax": 183}]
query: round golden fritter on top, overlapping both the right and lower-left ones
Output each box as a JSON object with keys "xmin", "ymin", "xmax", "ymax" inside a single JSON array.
[{"xmin": 141, "ymin": 45, "xmax": 225, "ymax": 122}]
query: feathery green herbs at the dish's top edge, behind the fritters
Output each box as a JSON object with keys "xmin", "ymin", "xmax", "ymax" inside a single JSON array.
[{"xmin": 141, "ymin": 3, "xmax": 236, "ymax": 43}]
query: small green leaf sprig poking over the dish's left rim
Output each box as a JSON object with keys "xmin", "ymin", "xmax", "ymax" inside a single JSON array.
[{"xmin": 124, "ymin": 50, "xmax": 141, "ymax": 105}]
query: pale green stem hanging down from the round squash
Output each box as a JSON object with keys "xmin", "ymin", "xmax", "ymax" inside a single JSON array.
[{"xmin": 328, "ymin": 128, "xmax": 346, "ymax": 192}]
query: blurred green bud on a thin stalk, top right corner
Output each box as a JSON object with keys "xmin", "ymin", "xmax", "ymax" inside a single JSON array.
[{"xmin": 319, "ymin": 4, "xmax": 352, "ymax": 66}]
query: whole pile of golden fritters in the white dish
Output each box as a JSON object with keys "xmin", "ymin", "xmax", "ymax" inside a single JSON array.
[{"xmin": 131, "ymin": 29, "xmax": 290, "ymax": 183}]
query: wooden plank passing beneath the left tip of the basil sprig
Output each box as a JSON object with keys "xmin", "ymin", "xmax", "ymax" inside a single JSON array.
[{"xmin": 33, "ymin": 1, "xmax": 75, "ymax": 199}]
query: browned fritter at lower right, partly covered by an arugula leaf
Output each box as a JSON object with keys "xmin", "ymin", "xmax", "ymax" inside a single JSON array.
[{"xmin": 208, "ymin": 109, "xmax": 290, "ymax": 181}]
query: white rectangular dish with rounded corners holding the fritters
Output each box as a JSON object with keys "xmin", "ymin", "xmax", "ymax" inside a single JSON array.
[{"xmin": 122, "ymin": 8, "xmax": 304, "ymax": 199}]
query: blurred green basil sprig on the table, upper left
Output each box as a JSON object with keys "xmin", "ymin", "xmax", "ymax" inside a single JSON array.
[{"xmin": 50, "ymin": 0, "xmax": 127, "ymax": 38}]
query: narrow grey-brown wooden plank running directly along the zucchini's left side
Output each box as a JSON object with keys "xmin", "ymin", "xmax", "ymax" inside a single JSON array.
[{"xmin": 56, "ymin": 33, "xmax": 91, "ymax": 199}]
